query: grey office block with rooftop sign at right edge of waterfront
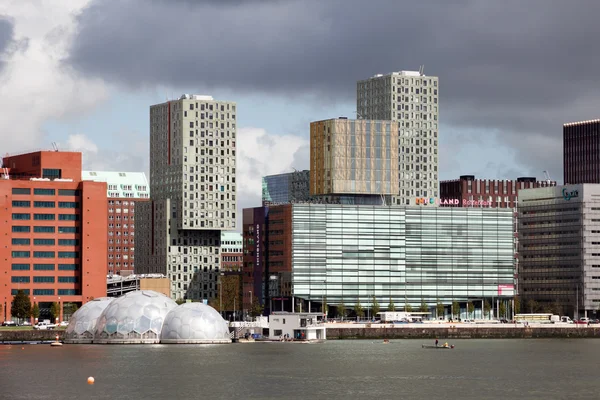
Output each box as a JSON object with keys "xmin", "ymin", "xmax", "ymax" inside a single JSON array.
[{"xmin": 518, "ymin": 184, "xmax": 600, "ymax": 317}]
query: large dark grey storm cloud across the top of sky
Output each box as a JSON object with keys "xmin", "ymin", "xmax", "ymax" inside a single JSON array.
[{"xmin": 68, "ymin": 0, "xmax": 600, "ymax": 180}]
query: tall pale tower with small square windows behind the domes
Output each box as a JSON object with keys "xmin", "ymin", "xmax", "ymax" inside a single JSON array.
[{"xmin": 135, "ymin": 95, "xmax": 237, "ymax": 300}]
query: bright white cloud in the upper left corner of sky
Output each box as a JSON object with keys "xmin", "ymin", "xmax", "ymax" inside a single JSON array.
[{"xmin": 0, "ymin": 0, "xmax": 108, "ymax": 153}]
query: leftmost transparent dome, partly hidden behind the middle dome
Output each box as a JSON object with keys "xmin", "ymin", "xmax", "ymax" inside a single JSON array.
[{"xmin": 65, "ymin": 297, "xmax": 114, "ymax": 343}]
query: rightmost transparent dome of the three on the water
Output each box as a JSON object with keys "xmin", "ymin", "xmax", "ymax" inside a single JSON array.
[{"xmin": 160, "ymin": 303, "xmax": 231, "ymax": 343}]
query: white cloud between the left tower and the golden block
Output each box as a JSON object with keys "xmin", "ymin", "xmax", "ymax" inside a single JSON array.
[{"xmin": 236, "ymin": 128, "xmax": 308, "ymax": 208}]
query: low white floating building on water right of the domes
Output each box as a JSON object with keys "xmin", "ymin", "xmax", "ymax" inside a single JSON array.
[{"xmin": 269, "ymin": 312, "xmax": 327, "ymax": 340}]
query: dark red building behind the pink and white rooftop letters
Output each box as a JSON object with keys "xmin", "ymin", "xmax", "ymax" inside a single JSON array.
[{"xmin": 438, "ymin": 175, "xmax": 556, "ymax": 208}]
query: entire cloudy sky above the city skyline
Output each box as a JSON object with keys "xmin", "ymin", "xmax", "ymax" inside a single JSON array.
[{"xmin": 0, "ymin": 0, "xmax": 600, "ymax": 216}]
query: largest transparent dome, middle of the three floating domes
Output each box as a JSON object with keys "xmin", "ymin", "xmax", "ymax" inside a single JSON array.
[{"xmin": 94, "ymin": 290, "xmax": 177, "ymax": 343}]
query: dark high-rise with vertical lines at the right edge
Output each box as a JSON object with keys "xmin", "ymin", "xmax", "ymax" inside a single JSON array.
[{"xmin": 563, "ymin": 119, "xmax": 600, "ymax": 185}]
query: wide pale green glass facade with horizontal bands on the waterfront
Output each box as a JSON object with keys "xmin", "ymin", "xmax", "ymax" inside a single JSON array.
[{"xmin": 292, "ymin": 204, "xmax": 514, "ymax": 309}]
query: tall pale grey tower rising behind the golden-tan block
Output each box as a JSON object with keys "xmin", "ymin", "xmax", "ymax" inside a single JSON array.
[{"xmin": 356, "ymin": 71, "xmax": 439, "ymax": 205}]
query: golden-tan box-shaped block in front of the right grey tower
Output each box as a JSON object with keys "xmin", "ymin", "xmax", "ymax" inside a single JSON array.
[{"xmin": 310, "ymin": 118, "xmax": 398, "ymax": 196}]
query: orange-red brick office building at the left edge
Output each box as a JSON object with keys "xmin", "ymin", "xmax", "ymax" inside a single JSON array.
[{"xmin": 0, "ymin": 151, "xmax": 107, "ymax": 320}]
